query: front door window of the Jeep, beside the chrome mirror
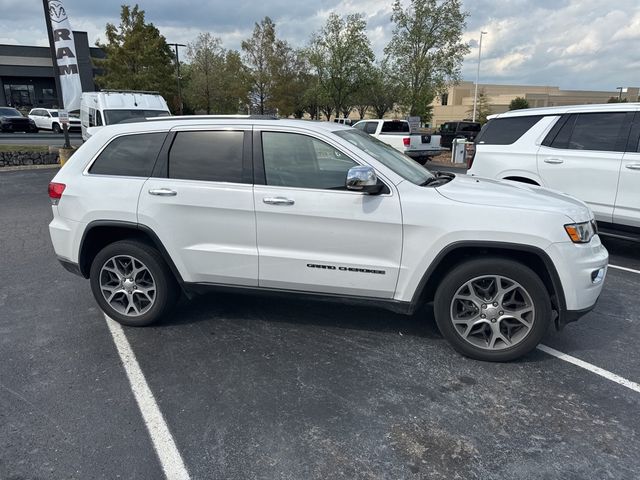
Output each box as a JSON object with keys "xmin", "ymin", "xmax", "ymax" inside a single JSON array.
[{"xmin": 262, "ymin": 132, "xmax": 357, "ymax": 190}]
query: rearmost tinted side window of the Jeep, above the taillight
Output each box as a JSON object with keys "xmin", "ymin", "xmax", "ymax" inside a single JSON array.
[{"xmin": 89, "ymin": 133, "xmax": 166, "ymax": 177}]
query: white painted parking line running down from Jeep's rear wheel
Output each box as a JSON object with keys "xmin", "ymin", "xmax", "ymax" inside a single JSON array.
[{"xmin": 104, "ymin": 315, "xmax": 190, "ymax": 480}]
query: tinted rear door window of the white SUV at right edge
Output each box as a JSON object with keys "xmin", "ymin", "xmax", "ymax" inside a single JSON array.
[{"xmin": 564, "ymin": 112, "xmax": 626, "ymax": 152}]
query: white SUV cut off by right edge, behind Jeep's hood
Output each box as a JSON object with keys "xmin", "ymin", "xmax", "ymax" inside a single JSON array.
[{"xmin": 469, "ymin": 103, "xmax": 640, "ymax": 239}]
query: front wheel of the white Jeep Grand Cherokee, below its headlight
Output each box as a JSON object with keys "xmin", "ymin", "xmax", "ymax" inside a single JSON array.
[{"xmin": 434, "ymin": 257, "xmax": 552, "ymax": 362}]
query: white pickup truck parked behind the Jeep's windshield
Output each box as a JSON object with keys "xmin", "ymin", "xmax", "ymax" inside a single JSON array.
[{"xmin": 354, "ymin": 119, "xmax": 443, "ymax": 165}]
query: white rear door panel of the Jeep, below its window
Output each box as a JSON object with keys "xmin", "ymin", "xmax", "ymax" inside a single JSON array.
[{"xmin": 138, "ymin": 178, "xmax": 258, "ymax": 286}]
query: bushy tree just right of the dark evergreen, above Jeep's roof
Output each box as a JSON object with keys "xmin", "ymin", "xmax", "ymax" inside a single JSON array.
[{"xmin": 185, "ymin": 33, "xmax": 249, "ymax": 114}]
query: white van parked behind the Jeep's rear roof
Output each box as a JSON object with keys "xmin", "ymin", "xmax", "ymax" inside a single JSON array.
[{"xmin": 80, "ymin": 90, "xmax": 171, "ymax": 140}]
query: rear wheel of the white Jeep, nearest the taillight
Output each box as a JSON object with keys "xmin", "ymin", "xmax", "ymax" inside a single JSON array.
[{"xmin": 90, "ymin": 240, "xmax": 179, "ymax": 327}]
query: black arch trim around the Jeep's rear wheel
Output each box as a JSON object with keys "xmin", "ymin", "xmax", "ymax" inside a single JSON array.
[{"xmin": 78, "ymin": 220, "xmax": 184, "ymax": 287}]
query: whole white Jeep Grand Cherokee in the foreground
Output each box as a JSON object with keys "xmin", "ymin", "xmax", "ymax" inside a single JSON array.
[{"xmin": 49, "ymin": 117, "xmax": 608, "ymax": 360}]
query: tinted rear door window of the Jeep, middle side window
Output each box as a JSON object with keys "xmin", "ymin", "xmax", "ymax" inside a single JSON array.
[{"xmin": 169, "ymin": 131, "xmax": 244, "ymax": 183}]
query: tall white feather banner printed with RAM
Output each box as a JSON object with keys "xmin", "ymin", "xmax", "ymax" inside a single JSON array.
[{"xmin": 47, "ymin": 0, "xmax": 82, "ymax": 111}]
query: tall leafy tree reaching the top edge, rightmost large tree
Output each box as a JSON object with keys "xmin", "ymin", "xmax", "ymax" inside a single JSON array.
[{"xmin": 384, "ymin": 0, "xmax": 469, "ymax": 121}]
